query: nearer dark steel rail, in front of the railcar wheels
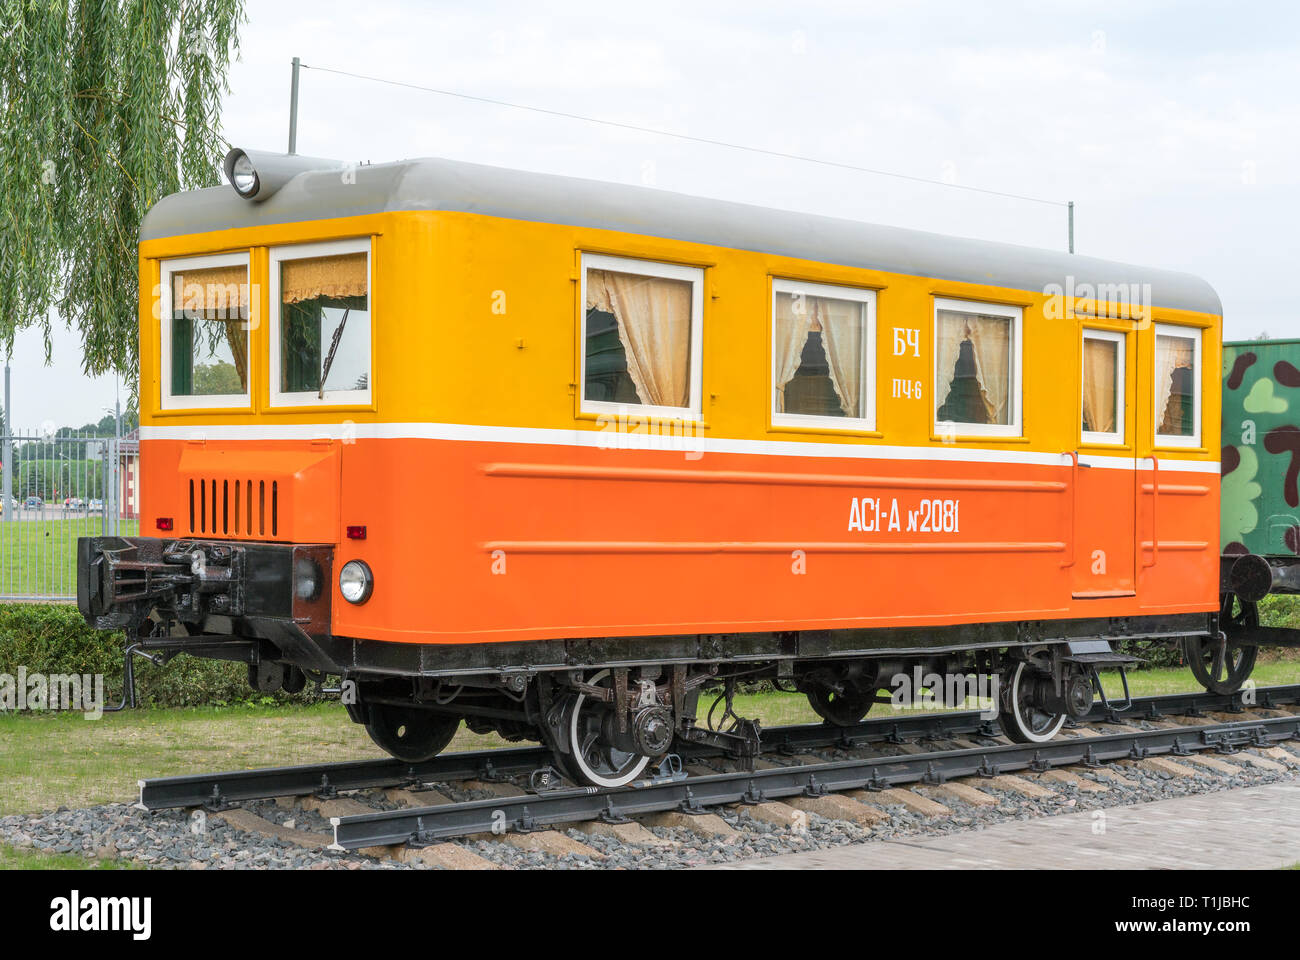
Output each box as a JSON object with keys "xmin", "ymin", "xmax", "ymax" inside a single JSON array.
[{"xmin": 330, "ymin": 715, "xmax": 1300, "ymax": 849}]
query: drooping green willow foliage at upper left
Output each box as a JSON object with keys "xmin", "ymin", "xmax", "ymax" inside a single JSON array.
[{"xmin": 0, "ymin": 0, "xmax": 244, "ymax": 384}]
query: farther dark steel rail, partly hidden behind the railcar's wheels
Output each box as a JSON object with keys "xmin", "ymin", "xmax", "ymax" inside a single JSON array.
[{"xmin": 139, "ymin": 684, "xmax": 1300, "ymax": 810}]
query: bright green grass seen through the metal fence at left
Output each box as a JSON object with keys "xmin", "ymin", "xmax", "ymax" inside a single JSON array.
[{"xmin": 0, "ymin": 514, "xmax": 139, "ymax": 597}]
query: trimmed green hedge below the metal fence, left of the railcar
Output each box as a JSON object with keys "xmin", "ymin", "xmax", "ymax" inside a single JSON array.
[{"xmin": 0, "ymin": 604, "xmax": 320, "ymax": 706}]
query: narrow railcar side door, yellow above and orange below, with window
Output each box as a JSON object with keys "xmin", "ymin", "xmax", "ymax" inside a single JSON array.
[{"xmin": 1070, "ymin": 327, "xmax": 1138, "ymax": 600}]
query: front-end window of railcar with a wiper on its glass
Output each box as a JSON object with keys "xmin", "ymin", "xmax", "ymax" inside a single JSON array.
[{"xmin": 270, "ymin": 239, "xmax": 371, "ymax": 406}]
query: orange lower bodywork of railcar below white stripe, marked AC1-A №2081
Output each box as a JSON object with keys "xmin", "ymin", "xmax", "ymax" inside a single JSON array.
[{"xmin": 143, "ymin": 438, "xmax": 1218, "ymax": 643}]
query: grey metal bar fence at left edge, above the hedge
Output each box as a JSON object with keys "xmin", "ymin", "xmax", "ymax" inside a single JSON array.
[{"xmin": 0, "ymin": 431, "xmax": 138, "ymax": 602}]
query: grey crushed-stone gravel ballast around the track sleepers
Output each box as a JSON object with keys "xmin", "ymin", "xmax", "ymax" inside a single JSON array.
[{"xmin": 0, "ymin": 743, "xmax": 1300, "ymax": 870}]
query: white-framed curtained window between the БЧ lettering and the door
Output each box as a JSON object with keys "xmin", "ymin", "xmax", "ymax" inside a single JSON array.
[{"xmin": 933, "ymin": 298, "xmax": 1023, "ymax": 437}]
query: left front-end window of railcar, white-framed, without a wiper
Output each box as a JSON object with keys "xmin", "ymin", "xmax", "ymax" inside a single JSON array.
[{"xmin": 160, "ymin": 254, "xmax": 250, "ymax": 410}]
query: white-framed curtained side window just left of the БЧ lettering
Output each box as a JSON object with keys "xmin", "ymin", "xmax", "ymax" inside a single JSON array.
[{"xmin": 772, "ymin": 280, "xmax": 876, "ymax": 429}]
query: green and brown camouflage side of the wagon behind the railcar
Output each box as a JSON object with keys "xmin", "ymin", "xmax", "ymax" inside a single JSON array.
[{"xmin": 1219, "ymin": 340, "xmax": 1300, "ymax": 557}]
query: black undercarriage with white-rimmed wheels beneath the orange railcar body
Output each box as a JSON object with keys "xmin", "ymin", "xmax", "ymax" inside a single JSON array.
[{"xmin": 325, "ymin": 641, "xmax": 1138, "ymax": 787}]
